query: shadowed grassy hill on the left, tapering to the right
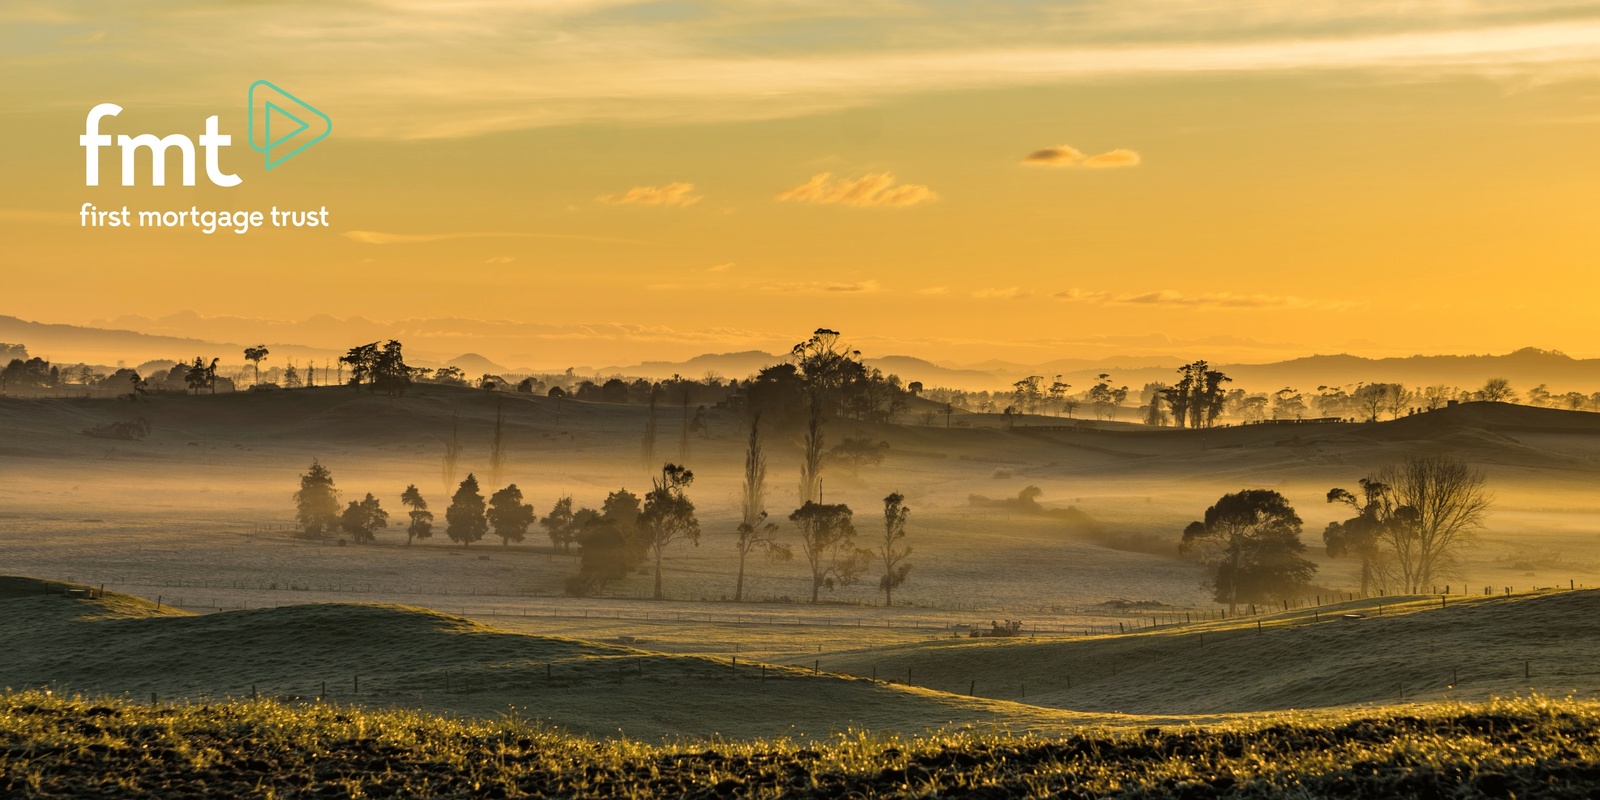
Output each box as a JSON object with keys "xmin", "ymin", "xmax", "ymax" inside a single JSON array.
[{"xmin": 0, "ymin": 578, "xmax": 1088, "ymax": 738}]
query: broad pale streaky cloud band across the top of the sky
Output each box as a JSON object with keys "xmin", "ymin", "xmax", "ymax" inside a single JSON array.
[{"xmin": 12, "ymin": 0, "xmax": 1600, "ymax": 139}]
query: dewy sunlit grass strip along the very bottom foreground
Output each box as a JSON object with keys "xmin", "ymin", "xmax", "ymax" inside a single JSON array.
[{"xmin": 0, "ymin": 691, "xmax": 1600, "ymax": 798}]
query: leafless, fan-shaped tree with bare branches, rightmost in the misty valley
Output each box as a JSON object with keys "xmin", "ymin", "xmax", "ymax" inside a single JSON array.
[{"xmin": 1378, "ymin": 456, "xmax": 1494, "ymax": 594}]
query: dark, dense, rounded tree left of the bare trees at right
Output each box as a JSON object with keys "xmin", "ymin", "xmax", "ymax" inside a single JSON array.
[{"xmin": 1178, "ymin": 490, "xmax": 1317, "ymax": 613}]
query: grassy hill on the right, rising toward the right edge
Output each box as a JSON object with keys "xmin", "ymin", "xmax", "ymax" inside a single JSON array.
[{"xmin": 812, "ymin": 590, "xmax": 1600, "ymax": 714}]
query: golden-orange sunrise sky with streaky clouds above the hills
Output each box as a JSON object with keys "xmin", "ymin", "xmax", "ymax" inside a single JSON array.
[{"xmin": 0, "ymin": 0, "xmax": 1600, "ymax": 368}]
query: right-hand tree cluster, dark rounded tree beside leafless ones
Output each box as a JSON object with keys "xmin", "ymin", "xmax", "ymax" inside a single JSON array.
[{"xmin": 1179, "ymin": 456, "xmax": 1493, "ymax": 613}]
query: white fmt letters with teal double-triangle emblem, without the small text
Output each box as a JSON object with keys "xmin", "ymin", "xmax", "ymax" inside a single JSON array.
[{"xmin": 78, "ymin": 80, "xmax": 333, "ymax": 187}]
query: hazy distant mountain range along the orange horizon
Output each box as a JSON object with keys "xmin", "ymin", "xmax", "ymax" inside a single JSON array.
[{"xmin": 0, "ymin": 315, "xmax": 1600, "ymax": 394}]
